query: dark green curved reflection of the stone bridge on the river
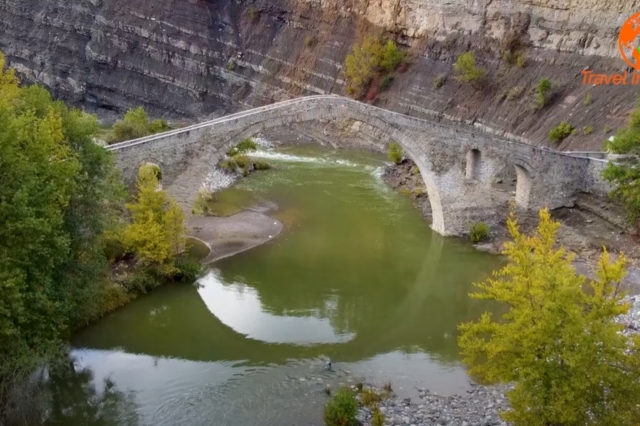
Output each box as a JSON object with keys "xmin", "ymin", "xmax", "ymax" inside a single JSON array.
[{"xmin": 74, "ymin": 236, "xmax": 496, "ymax": 364}]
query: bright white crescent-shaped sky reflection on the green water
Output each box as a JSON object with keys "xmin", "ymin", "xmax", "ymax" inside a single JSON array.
[{"xmin": 198, "ymin": 270, "xmax": 354, "ymax": 345}]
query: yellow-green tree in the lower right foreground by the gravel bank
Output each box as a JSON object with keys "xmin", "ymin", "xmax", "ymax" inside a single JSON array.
[{"xmin": 459, "ymin": 209, "xmax": 640, "ymax": 426}]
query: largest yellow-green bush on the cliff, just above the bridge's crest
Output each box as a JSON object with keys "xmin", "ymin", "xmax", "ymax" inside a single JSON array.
[{"xmin": 345, "ymin": 37, "xmax": 405, "ymax": 96}]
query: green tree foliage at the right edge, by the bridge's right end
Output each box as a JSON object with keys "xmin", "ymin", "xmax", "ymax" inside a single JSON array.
[{"xmin": 602, "ymin": 103, "xmax": 640, "ymax": 228}]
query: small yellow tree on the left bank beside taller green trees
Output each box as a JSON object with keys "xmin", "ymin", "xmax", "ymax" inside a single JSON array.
[{"xmin": 123, "ymin": 165, "xmax": 185, "ymax": 273}]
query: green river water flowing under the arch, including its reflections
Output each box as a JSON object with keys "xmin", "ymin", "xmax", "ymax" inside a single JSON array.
[{"xmin": 55, "ymin": 146, "xmax": 499, "ymax": 426}]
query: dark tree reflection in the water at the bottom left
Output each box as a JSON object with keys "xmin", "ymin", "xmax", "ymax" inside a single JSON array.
[{"xmin": 44, "ymin": 357, "xmax": 139, "ymax": 426}]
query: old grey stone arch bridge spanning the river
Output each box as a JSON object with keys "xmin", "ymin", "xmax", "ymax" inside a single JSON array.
[{"xmin": 107, "ymin": 95, "xmax": 608, "ymax": 235}]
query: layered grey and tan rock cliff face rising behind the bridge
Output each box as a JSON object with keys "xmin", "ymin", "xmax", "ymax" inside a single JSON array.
[{"xmin": 0, "ymin": 0, "xmax": 640, "ymax": 149}]
